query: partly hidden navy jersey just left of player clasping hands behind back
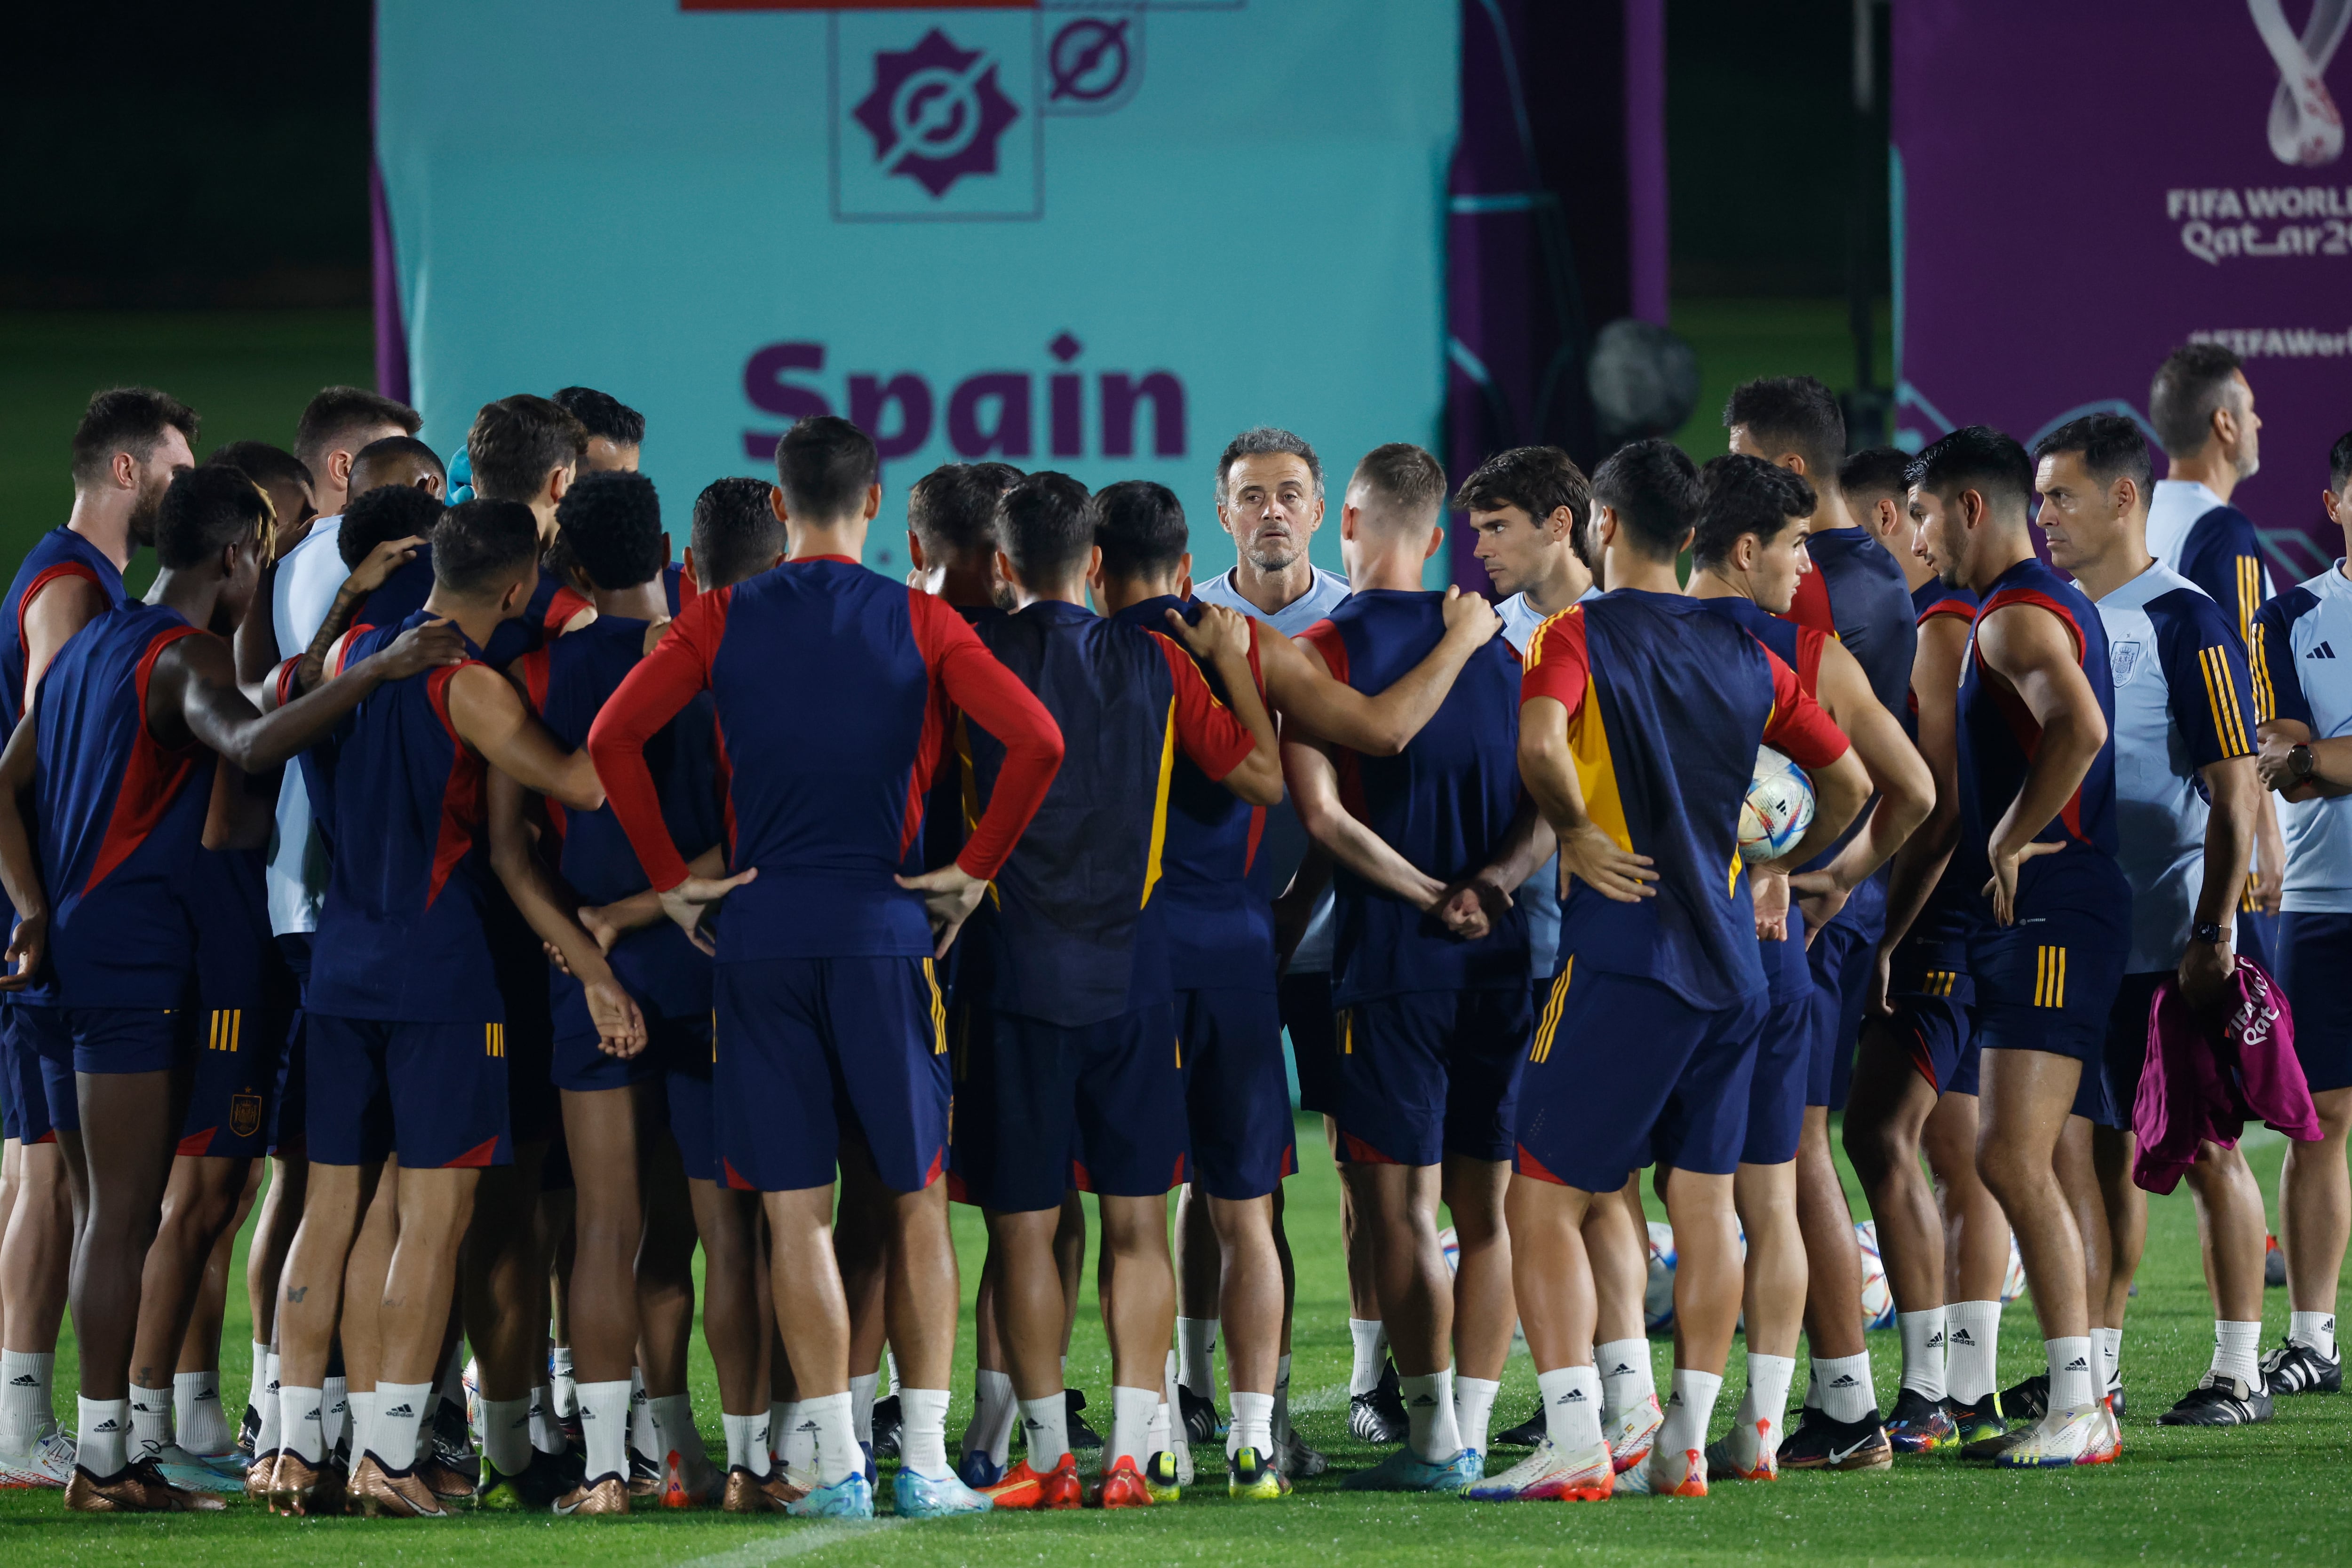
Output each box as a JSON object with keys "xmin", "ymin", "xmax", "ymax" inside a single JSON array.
[{"xmin": 1112, "ymin": 597, "xmax": 1275, "ymax": 992}]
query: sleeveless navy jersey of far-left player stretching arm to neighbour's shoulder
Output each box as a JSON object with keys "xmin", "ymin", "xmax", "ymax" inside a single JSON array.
[{"xmin": 26, "ymin": 604, "xmax": 214, "ymax": 1008}]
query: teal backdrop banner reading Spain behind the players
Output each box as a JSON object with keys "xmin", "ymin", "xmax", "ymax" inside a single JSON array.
[{"xmin": 376, "ymin": 0, "xmax": 1461, "ymax": 576}]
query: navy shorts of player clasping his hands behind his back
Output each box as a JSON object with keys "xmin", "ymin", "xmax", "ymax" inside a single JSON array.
[{"xmin": 1336, "ymin": 985, "xmax": 1536, "ymax": 1166}]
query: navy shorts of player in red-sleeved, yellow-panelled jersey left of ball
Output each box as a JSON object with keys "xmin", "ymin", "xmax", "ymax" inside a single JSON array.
[{"xmin": 1512, "ymin": 959, "xmax": 1771, "ymax": 1192}]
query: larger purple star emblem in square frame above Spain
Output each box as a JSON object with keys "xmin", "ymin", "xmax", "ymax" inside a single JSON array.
[{"xmin": 830, "ymin": 12, "xmax": 1042, "ymax": 221}]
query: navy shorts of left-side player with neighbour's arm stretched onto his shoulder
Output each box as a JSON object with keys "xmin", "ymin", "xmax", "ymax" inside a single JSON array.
[{"xmin": 306, "ymin": 1013, "xmax": 515, "ymax": 1171}]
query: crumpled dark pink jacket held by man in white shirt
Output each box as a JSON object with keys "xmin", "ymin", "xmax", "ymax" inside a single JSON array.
[{"xmin": 2131, "ymin": 959, "xmax": 2319, "ymax": 1192}]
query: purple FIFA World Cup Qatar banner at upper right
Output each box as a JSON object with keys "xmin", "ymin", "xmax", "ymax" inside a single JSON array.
[{"xmin": 1893, "ymin": 0, "xmax": 2352, "ymax": 583}]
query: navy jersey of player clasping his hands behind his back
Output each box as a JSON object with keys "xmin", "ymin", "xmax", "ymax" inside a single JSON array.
[{"xmin": 1305, "ymin": 588, "xmax": 1529, "ymax": 1006}]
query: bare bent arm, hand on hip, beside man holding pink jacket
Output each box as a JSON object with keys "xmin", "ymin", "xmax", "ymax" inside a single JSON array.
[{"xmin": 1976, "ymin": 604, "xmax": 2107, "ymax": 926}]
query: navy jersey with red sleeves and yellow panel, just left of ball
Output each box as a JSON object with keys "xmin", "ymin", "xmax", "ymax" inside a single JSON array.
[{"xmin": 1522, "ymin": 588, "xmax": 1846, "ymax": 1011}]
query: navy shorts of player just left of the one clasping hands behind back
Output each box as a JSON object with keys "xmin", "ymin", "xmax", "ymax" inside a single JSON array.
[{"xmin": 1176, "ymin": 990, "xmax": 1298, "ymax": 1199}]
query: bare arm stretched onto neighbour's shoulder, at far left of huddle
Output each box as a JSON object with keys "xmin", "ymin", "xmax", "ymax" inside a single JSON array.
[{"xmin": 160, "ymin": 626, "xmax": 466, "ymax": 774}]
